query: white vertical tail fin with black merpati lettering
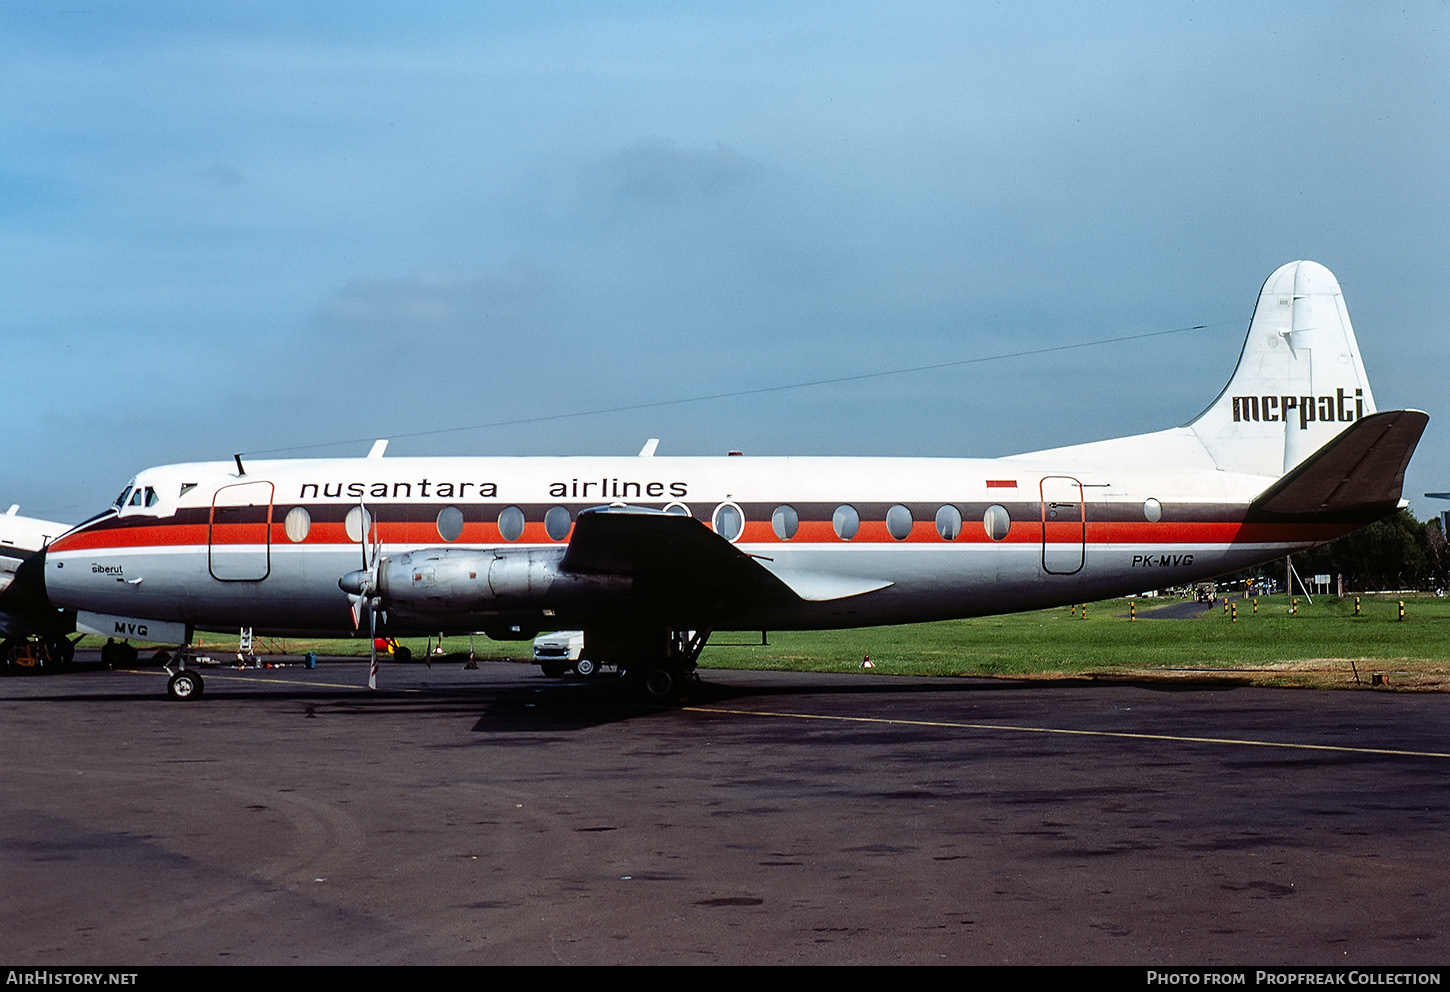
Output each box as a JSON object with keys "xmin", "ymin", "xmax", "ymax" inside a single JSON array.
[{"xmin": 1188, "ymin": 261, "xmax": 1380, "ymax": 478}]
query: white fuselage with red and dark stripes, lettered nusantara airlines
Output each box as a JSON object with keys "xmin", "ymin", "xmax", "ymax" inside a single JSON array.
[{"xmin": 45, "ymin": 452, "xmax": 1349, "ymax": 634}]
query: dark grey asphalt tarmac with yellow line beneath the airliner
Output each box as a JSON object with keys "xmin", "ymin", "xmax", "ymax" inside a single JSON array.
[{"xmin": 0, "ymin": 660, "xmax": 1450, "ymax": 966}]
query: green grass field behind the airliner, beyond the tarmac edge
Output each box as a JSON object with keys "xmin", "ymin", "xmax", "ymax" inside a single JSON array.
[{"xmin": 107, "ymin": 596, "xmax": 1450, "ymax": 689}]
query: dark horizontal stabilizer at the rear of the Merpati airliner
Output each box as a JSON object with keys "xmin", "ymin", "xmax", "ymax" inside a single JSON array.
[{"xmin": 1248, "ymin": 410, "xmax": 1430, "ymax": 519}]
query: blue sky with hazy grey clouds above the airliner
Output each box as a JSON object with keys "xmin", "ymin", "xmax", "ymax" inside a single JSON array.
[{"xmin": 0, "ymin": 0, "xmax": 1450, "ymax": 519}]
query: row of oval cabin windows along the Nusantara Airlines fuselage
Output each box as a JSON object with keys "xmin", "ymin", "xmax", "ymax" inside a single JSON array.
[{"xmin": 283, "ymin": 503, "xmax": 1012, "ymax": 542}]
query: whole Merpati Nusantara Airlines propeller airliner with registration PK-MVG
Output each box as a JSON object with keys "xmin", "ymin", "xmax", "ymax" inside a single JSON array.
[{"xmin": 11, "ymin": 261, "xmax": 1428, "ymax": 699}]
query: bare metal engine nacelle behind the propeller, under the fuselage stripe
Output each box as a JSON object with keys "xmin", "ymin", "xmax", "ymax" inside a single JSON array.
[{"xmin": 378, "ymin": 548, "xmax": 632, "ymax": 615}]
